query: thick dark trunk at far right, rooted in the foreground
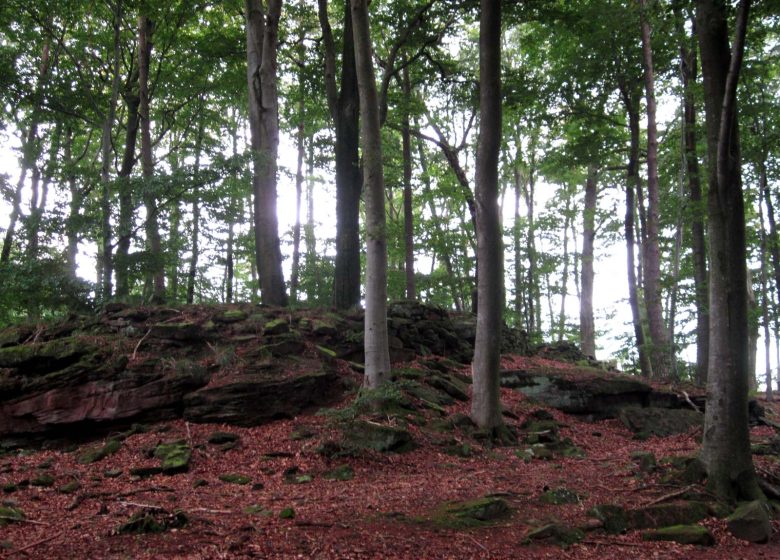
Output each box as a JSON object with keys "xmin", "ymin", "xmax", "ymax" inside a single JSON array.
[{"xmin": 696, "ymin": 0, "xmax": 762, "ymax": 500}]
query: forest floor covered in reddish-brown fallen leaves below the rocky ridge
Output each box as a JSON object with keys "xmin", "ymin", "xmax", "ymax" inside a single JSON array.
[{"xmin": 0, "ymin": 357, "xmax": 780, "ymax": 560}]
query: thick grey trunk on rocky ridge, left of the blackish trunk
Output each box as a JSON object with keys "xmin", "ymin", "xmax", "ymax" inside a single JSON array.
[{"xmin": 246, "ymin": 0, "xmax": 287, "ymax": 306}]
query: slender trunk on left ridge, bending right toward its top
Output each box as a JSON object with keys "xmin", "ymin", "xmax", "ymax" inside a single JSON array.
[{"xmin": 98, "ymin": 0, "xmax": 123, "ymax": 299}]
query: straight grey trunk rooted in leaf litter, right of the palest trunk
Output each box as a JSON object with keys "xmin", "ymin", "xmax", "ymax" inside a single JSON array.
[{"xmin": 471, "ymin": 0, "xmax": 504, "ymax": 432}]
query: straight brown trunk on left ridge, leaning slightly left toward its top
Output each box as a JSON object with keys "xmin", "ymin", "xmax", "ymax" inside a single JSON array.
[{"xmin": 138, "ymin": 15, "xmax": 165, "ymax": 304}]
